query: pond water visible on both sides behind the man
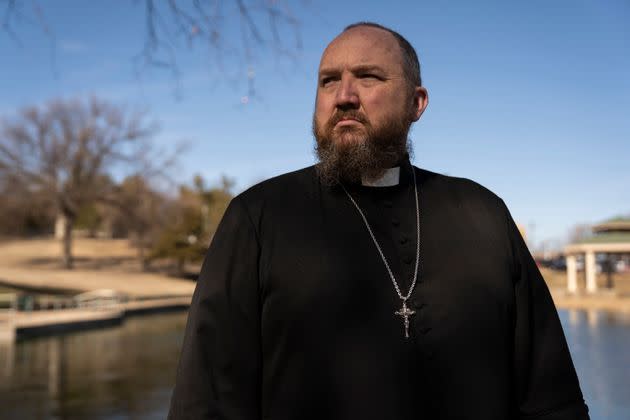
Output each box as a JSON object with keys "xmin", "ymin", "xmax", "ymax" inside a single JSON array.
[{"xmin": 0, "ymin": 311, "xmax": 630, "ymax": 420}]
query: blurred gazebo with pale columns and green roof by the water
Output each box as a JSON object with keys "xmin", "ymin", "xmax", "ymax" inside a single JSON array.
[{"xmin": 564, "ymin": 218, "xmax": 630, "ymax": 293}]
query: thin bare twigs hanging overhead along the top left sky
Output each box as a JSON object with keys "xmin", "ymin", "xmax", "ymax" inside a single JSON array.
[{"xmin": 0, "ymin": 0, "xmax": 307, "ymax": 98}]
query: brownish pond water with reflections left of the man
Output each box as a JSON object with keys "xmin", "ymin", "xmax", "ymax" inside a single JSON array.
[{"xmin": 0, "ymin": 313, "xmax": 186, "ymax": 419}]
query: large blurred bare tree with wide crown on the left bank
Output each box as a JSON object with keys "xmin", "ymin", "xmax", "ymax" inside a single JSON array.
[{"xmin": 0, "ymin": 98, "xmax": 173, "ymax": 268}]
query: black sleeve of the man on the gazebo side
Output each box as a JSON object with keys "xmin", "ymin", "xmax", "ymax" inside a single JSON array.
[{"xmin": 501, "ymin": 203, "xmax": 589, "ymax": 420}]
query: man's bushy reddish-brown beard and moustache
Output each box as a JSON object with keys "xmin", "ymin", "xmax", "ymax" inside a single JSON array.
[{"xmin": 313, "ymin": 110, "xmax": 411, "ymax": 186}]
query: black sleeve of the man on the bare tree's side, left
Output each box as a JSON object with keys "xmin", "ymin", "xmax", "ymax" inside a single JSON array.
[{"xmin": 168, "ymin": 197, "xmax": 261, "ymax": 420}]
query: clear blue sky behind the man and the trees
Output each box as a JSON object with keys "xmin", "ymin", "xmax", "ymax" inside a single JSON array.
[{"xmin": 0, "ymin": 0, "xmax": 630, "ymax": 246}]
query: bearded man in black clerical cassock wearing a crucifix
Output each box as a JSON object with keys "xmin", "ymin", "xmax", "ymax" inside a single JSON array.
[{"xmin": 170, "ymin": 23, "xmax": 588, "ymax": 420}]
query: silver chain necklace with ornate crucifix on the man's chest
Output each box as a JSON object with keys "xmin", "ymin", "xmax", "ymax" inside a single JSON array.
[{"xmin": 340, "ymin": 166, "xmax": 420, "ymax": 338}]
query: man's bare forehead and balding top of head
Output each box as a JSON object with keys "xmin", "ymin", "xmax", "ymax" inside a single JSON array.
[{"xmin": 319, "ymin": 26, "xmax": 403, "ymax": 71}]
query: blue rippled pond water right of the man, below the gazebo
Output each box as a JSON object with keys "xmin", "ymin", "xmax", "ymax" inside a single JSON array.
[{"xmin": 560, "ymin": 310, "xmax": 630, "ymax": 420}]
